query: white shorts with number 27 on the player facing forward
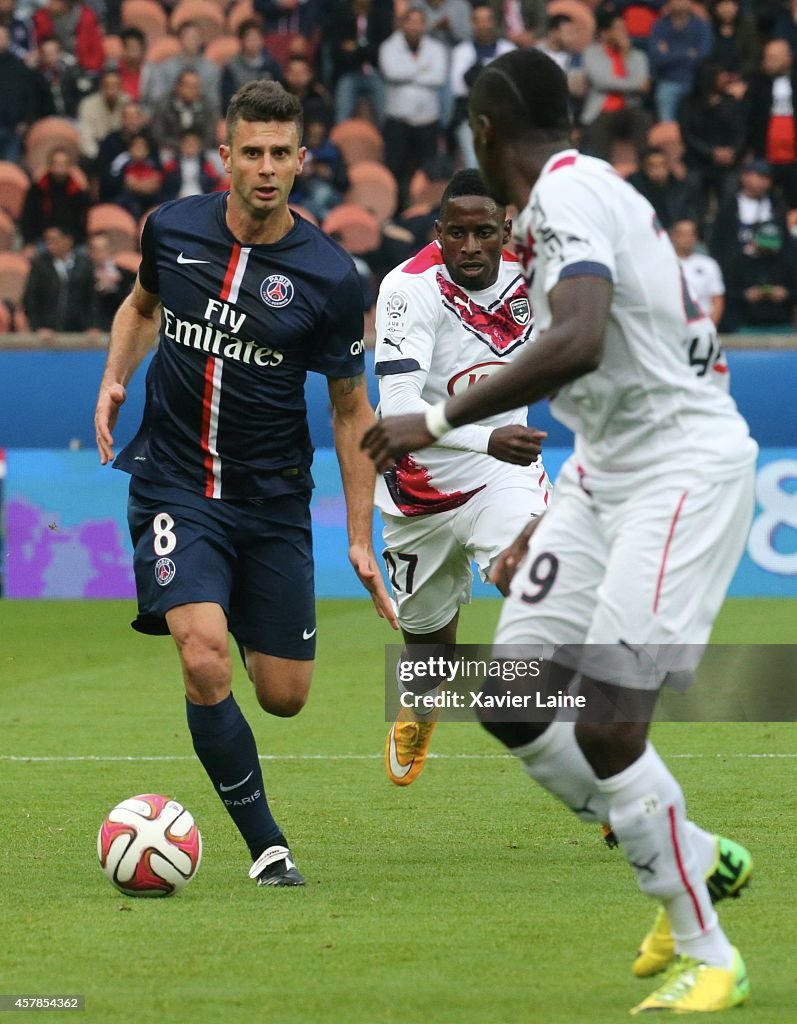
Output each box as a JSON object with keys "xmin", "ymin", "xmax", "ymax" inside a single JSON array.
[{"xmin": 382, "ymin": 478, "xmax": 547, "ymax": 635}]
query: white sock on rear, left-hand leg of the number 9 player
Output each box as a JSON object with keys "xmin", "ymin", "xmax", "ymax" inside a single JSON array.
[{"xmin": 509, "ymin": 721, "xmax": 609, "ymax": 822}]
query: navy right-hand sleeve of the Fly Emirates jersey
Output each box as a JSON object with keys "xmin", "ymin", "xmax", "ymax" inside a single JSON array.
[{"xmin": 307, "ymin": 264, "xmax": 366, "ymax": 380}]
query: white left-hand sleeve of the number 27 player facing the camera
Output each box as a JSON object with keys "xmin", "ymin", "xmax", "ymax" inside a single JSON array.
[{"xmin": 374, "ymin": 274, "xmax": 442, "ymax": 380}]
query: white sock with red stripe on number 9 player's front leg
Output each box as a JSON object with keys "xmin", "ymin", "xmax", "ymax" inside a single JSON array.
[{"xmin": 597, "ymin": 743, "xmax": 733, "ymax": 969}]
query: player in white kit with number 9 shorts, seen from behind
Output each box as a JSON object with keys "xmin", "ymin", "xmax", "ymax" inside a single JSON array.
[{"xmin": 364, "ymin": 50, "xmax": 757, "ymax": 1014}]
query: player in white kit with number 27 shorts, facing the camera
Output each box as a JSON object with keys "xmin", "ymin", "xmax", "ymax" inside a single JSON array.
[{"xmin": 375, "ymin": 170, "xmax": 548, "ymax": 785}]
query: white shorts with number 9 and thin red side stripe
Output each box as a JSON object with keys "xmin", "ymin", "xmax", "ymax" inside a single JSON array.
[{"xmin": 495, "ymin": 464, "xmax": 755, "ymax": 689}]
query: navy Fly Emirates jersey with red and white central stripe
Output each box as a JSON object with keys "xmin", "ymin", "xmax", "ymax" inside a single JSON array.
[{"xmin": 115, "ymin": 193, "xmax": 365, "ymax": 499}]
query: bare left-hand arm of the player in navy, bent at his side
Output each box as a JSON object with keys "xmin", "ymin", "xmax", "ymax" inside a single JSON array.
[{"xmin": 94, "ymin": 280, "xmax": 161, "ymax": 466}]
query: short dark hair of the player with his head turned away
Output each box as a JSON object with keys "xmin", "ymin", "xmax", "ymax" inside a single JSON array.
[{"xmin": 469, "ymin": 49, "xmax": 571, "ymax": 142}]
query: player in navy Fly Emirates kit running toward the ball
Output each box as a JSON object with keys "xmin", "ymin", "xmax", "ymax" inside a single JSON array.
[{"xmin": 95, "ymin": 81, "xmax": 397, "ymax": 886}]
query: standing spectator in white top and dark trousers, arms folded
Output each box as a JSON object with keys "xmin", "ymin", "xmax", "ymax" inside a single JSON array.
[{"xmin": 379, "ymin": 7, "xmax": 449, "ymax": 206}]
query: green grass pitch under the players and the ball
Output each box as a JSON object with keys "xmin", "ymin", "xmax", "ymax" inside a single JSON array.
[{"xmin": 0, "ymin": 600, "xmax": 797, "ymax": 1024}]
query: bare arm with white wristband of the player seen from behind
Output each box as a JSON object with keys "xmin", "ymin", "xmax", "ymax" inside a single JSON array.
[{"xmin": 363, "ymin": 275, "xmax": 613, "ymax": 471}]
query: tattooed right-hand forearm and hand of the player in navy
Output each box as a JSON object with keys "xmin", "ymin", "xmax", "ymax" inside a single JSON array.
[{"xmin": 328, "ymin": 374, "xmax": 399, "ymax": 630}]
